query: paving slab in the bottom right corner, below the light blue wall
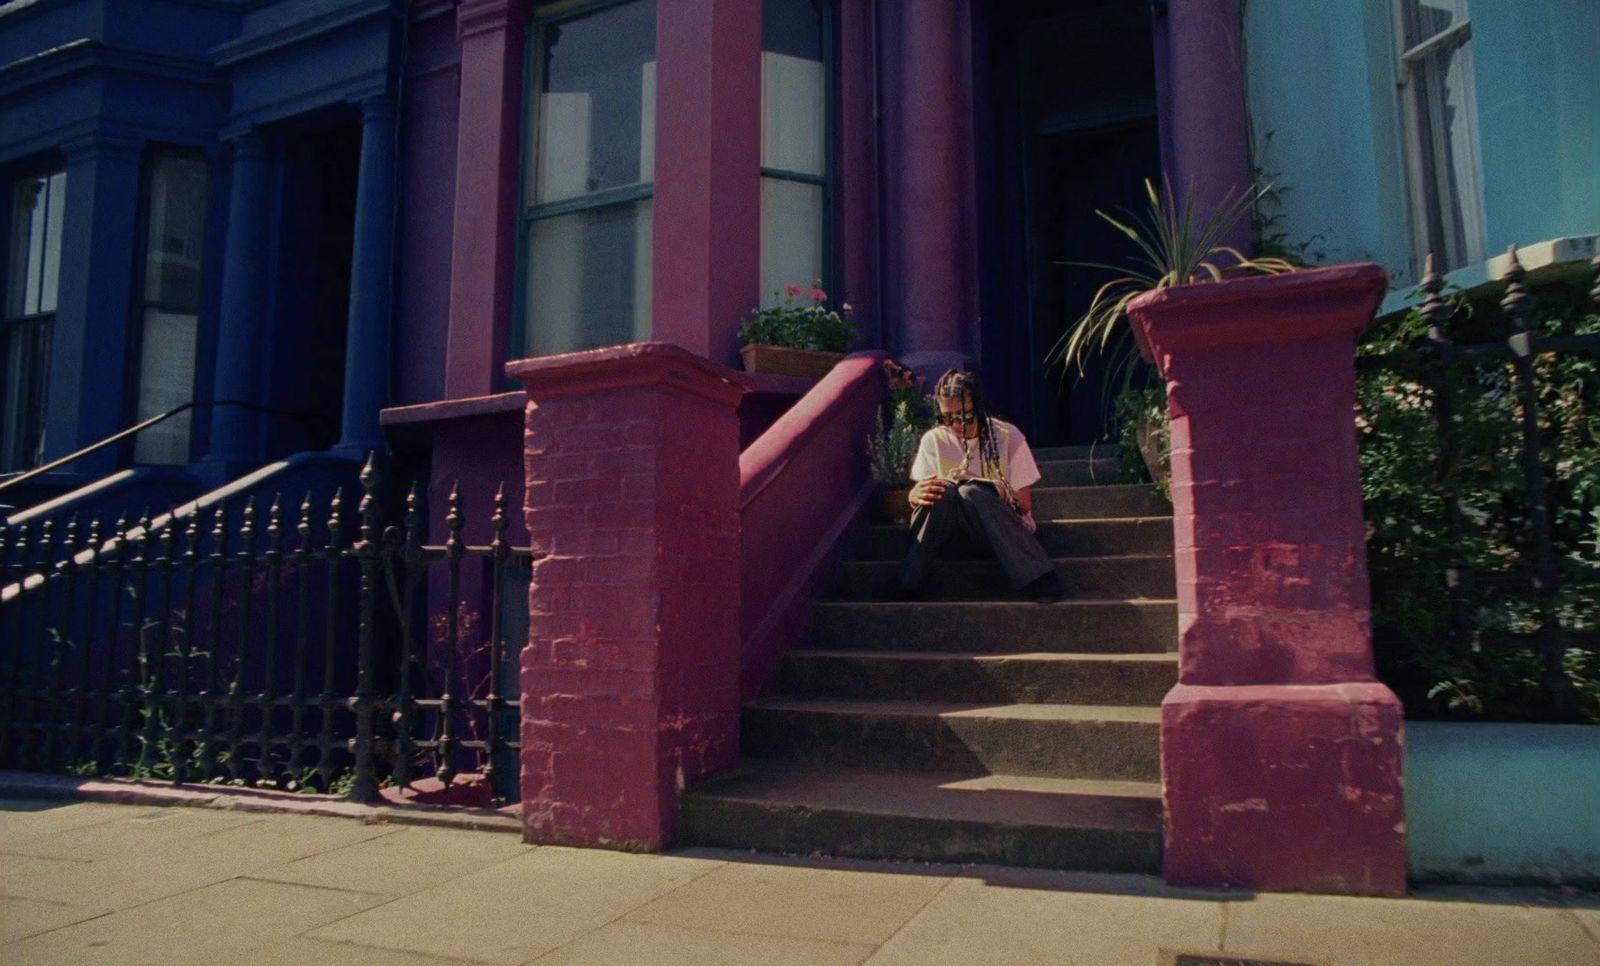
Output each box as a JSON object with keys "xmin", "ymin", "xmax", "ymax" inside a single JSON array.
[{"xmin": 1222, "ymin": 894, "xmax": 1600, "ymax": 966}]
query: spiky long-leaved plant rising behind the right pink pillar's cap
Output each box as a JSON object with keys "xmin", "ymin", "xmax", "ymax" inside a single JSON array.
[{"xmin": 1045, "ymin": 176, "xmax": 1294, "ymax": 380}]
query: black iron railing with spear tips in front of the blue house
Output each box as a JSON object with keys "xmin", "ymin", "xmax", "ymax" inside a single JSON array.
[{"xmin": 0, "ymin": 459, "xmax": 531, "ymax": 800}]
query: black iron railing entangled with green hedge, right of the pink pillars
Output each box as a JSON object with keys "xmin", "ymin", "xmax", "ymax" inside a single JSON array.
[{"xmin": 1358, "ymin": 249, "xmax": 1600, "ymax": 720}]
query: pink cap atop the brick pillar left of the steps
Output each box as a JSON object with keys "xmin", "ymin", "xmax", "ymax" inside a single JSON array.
[{"xmin": 506, "ymin": 342, "xmax": 750, "ymax": 406}]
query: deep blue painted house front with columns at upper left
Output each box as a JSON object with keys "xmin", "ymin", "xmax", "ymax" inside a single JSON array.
[{"xmin": 0, "ymin": 0, "xmax": 405, "ymax": 524}]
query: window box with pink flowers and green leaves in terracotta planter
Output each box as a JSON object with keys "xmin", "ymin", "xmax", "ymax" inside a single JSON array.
[{"xmin": 739, "ymin": 285, "xmax": 858, "ymax": 379}]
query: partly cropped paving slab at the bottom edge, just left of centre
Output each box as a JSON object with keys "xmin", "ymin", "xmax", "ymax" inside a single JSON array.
[{"xmin": 534, "ymin": 921, "xmax": 874, "ymax": 966}]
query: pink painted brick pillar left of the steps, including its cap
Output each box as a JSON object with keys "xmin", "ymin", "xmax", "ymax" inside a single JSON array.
[{"xmin": 507, "ymin": 342, "xmax": 744, "ymax": 849}]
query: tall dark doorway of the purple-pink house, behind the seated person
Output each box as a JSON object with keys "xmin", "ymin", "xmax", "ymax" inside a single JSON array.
[{"xmin": 979, "ymin": 0, "xmax": 1160, "ymax": 446}]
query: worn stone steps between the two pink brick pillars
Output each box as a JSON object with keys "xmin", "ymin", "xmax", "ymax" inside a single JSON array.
[{"xmin": 682, "ymin": 446, "xmax": 1178, "ymax": 873}]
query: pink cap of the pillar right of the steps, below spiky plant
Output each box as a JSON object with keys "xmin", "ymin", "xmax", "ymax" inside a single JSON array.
[{"xmin": 1128, "ymin": 262, "xmax": 1389, "ymax": 374}]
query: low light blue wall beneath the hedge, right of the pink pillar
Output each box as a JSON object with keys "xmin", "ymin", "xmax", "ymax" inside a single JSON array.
[{"xmin": 1405, "ymin": 721, "xmax": 1600, "ymax": 883}]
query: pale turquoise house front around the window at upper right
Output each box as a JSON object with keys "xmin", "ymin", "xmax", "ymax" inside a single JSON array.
[{"xmin": 1243, "ymin": 0, "xmax": 1600, "ymax": 289}]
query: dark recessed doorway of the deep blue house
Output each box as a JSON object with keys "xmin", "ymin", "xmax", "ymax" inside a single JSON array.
[{"xmin": 267, "ymin": 110, "xmax": 362, "ymax": 454}]
